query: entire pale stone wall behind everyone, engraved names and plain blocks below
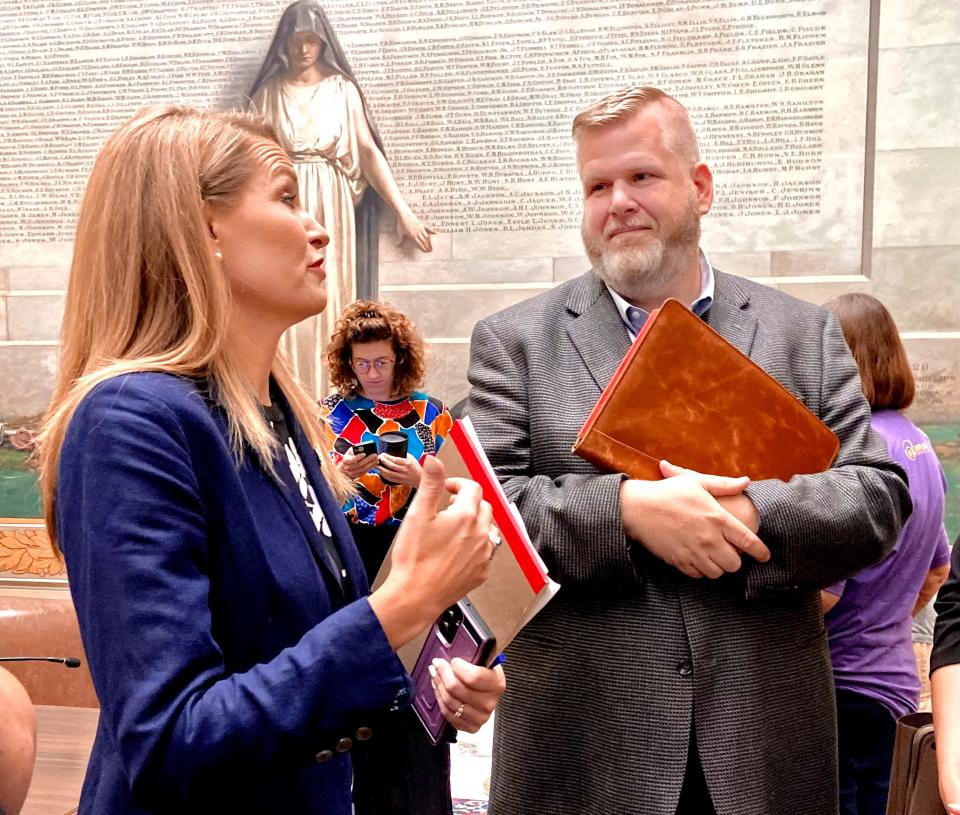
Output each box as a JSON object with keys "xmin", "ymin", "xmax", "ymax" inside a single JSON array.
[{"xmin": 0, "ymin": 0, "xmax": 960, "ymax": 428}]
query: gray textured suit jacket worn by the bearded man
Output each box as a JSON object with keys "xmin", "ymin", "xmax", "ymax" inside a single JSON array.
[{"xmin": 467, "ymin": 272, "xmax": 910, "ymax": 815}]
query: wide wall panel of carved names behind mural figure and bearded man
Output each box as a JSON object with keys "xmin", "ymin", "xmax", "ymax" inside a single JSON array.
[{"xmin": 0, "ymin": 0, "xmax": 868, "ymax": 250}]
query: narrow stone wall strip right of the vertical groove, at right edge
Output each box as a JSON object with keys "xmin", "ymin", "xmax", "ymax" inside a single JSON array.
[{"xmin": 868, "ymin": 0, "xmax": 960, "ymax": 423}]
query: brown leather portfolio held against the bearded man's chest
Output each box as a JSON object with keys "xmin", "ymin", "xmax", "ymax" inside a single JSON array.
[{"xmin": 573, "ymin": 299, "xmax": 840, "ymax": 481}]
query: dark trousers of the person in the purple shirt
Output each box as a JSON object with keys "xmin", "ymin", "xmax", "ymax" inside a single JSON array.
[{"xmin": 837, "ymin": 690, "xmax": 897, "ymax": 815}]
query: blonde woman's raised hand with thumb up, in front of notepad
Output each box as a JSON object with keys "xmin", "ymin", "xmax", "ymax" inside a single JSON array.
[{"xmin": 370, "ymin": 456, "xmax": 493, "ymax": 649}]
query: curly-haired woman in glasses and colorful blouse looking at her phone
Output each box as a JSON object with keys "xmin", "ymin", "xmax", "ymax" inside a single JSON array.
[{"xmin": 321, "ymin": 300, "xmax": 453, "ymax": 815}]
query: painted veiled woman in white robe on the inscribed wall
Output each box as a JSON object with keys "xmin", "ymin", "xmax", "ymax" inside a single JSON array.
[{"xmin": 250, "ymin": 0, "xmax": 432, "ymax": 398}]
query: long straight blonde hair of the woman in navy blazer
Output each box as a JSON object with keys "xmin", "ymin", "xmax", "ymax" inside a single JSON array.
[{"xmin": 39, "ymin": 106, "xmax": 350, "ymax": 544}]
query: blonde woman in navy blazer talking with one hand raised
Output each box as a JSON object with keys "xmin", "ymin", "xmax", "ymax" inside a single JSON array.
[{"xmin": 41, "ymin": 108, "xmax": 504, "ymax": 815}]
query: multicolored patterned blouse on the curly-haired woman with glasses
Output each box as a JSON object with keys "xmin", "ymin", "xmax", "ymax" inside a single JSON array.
[{"xmin": 320, "ymin": 391, "xmax": 453, "ymax": 526}]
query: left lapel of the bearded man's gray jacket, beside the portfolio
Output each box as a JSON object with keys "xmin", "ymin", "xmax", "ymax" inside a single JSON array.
[{"xmin": 567, "ymin": 271, "xmax": 630, "ymax": 390}]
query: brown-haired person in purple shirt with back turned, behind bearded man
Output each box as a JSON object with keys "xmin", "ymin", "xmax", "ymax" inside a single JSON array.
[{"xmin": 822, "ymin": 293, "xmax": 950, "ymax": 815}]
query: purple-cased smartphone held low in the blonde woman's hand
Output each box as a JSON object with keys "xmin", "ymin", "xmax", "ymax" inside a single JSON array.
[{"xmin": 411, "ymin": 598, "xmax": 495, "ymax": 744}]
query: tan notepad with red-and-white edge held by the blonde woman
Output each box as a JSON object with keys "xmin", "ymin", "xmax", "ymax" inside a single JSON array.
[{"xmin": 373, "ymin": 417, "xmax": 560, "ymax": 671}]
